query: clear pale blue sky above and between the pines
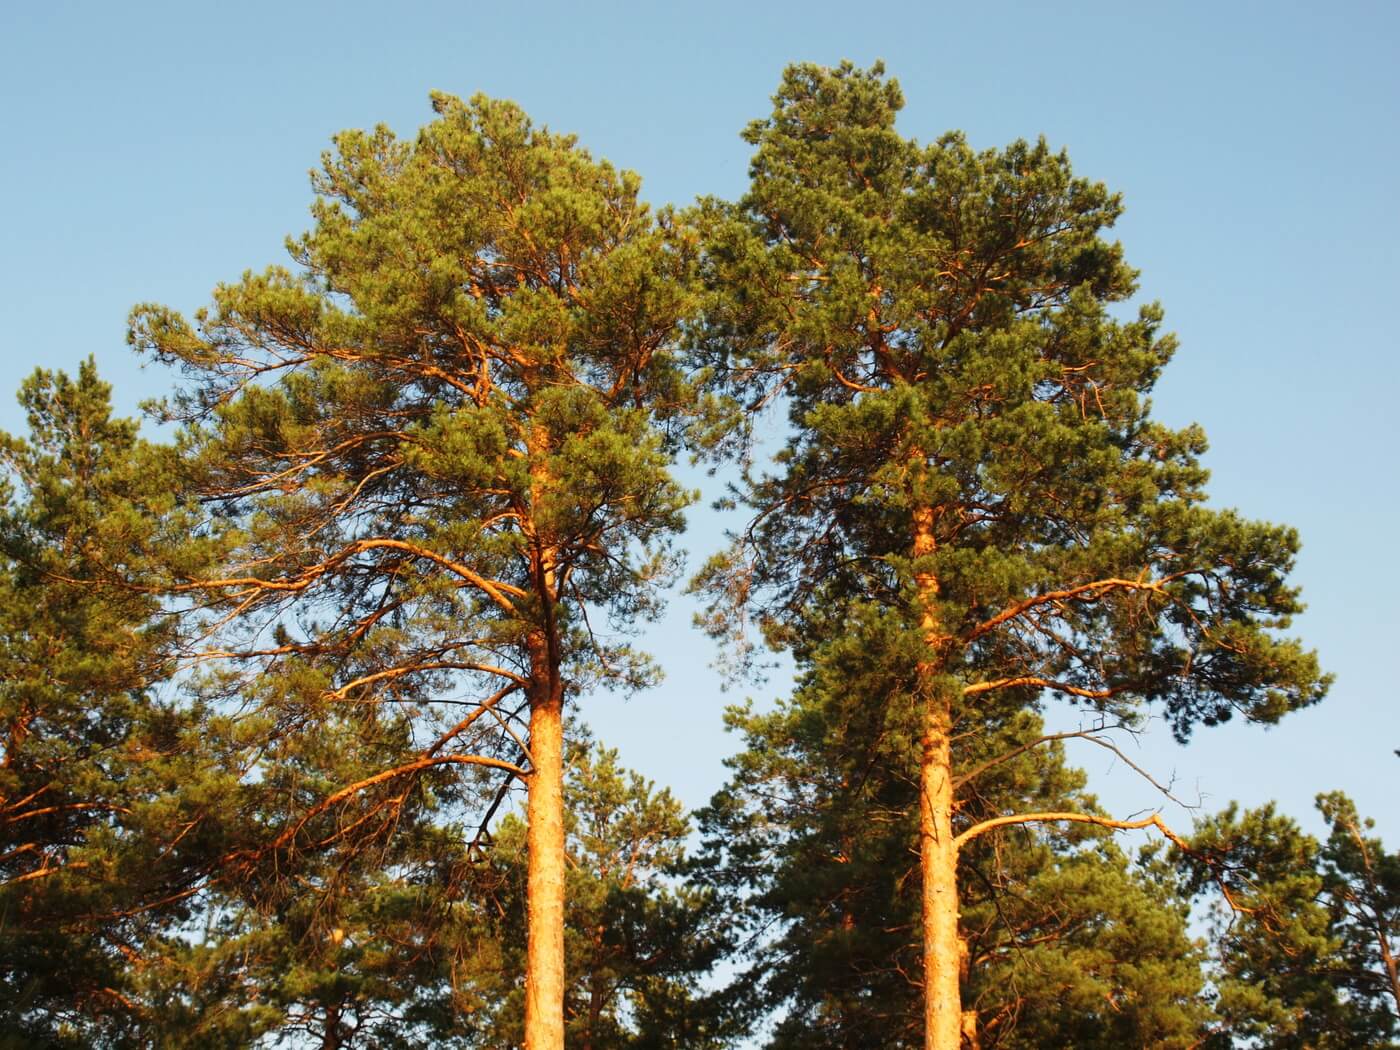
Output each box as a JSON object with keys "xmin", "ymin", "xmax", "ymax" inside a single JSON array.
[{"xmin": 0, "ymin": 0, "xmax": 1400, "ymax": 846}]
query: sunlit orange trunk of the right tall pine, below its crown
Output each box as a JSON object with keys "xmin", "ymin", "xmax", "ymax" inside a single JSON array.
[{"xmin": 913, "ymin": 501, "xmax": 963, "ymax": 1050}]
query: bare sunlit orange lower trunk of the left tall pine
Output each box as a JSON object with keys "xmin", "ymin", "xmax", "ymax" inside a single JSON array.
[{"xmin": 525, "ymin": 686, "xmax": 564, "ymax": 1050}]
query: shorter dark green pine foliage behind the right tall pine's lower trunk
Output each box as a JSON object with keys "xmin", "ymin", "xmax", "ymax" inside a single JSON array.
[{"xmin": 701, "ymin": 638, "xmax": 1212, "ymax": 1050}]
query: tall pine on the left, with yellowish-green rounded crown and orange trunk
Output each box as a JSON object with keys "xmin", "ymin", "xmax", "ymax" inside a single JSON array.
[{"xmin": 130, "ymin": 95, "xmax": 690, "ymax": 1050}]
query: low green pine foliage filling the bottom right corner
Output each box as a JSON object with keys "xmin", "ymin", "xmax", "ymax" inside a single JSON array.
[{"xmin": 1179, "ymin": 792, "xmax": 1400, "ymax": 1050}]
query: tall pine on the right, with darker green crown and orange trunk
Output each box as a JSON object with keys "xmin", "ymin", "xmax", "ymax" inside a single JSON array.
[{"xmin": 696, "ymin": 64, "xmax": 1326, "ymax": 1050}]
